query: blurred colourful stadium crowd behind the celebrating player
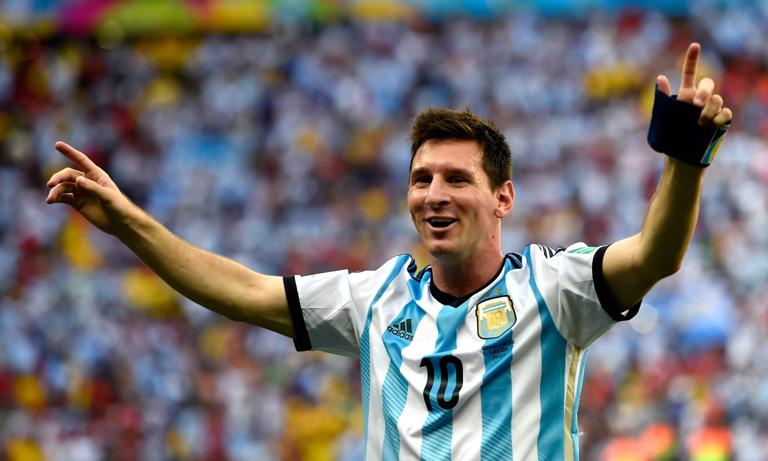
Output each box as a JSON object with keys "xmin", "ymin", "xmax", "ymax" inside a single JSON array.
[{"xmin": 0, "ymin": 0, "xmax": 768, "ymax": 461}]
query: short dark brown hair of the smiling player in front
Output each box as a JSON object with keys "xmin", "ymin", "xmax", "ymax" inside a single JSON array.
[{"xmin": 409, "ymin": 108, "xmax": 512, "ymax": 190}]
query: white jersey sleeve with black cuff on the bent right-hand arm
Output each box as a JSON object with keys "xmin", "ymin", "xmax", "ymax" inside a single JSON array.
[{"xmin": 529, "ymin": 243, "xmax": 640, "ymax": 347}]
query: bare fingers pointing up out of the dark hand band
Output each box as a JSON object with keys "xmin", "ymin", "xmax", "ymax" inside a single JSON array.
[{"xmin": 656, "ymin": 42, "xmax": 733, "ymax": 126}]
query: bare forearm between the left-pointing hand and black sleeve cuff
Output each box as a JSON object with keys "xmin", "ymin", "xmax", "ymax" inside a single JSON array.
[{"xmin": 116, "ymin": 208, "xmax": 293, "ymax": 336}]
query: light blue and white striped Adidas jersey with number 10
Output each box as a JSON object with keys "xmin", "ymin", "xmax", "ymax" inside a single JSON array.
[{"xmin": 284, "ymin": 243, "xmax": 639, "ymax": 461}]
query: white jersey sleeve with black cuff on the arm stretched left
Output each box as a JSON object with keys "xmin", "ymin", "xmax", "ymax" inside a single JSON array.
[{"xmin": 283, "ymin": 256, "xmax": 412, "ymax": 356}]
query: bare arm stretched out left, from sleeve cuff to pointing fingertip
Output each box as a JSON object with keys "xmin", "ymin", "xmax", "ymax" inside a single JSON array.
[{"xmin": 46, "ymin": 142, "xmax": 293, "ymax": 337}]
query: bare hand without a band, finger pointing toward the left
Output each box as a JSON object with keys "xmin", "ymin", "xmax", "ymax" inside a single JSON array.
[{"xmin": 45, "ymin": 141, "xmax": 135, "ymax": 235}]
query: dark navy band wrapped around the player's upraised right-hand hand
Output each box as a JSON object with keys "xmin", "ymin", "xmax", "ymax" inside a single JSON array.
[{"xmin": 648, "ymin": 85, "xmax": 731, "ymax": 167}]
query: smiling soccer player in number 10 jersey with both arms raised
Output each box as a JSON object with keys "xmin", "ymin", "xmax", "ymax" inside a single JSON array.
[{"xmin": 47, "ymin": 43, "xmax": 732, "ymax": 461}]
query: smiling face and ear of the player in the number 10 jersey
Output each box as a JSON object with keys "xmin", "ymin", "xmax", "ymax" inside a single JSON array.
[{"xmin": 408, "ymin": 139, "xmax": 514, "ymax": 263}]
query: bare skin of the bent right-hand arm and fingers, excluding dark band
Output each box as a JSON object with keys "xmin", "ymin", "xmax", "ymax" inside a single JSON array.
[{"xmin": 603, "ymin": 43, "xmax": 733, "ymax": 307}]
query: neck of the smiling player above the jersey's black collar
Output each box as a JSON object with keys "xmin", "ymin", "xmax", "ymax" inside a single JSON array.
[{"xmin": 430, "ymin": 250, "xmax": 504, "ymax": 297}]
